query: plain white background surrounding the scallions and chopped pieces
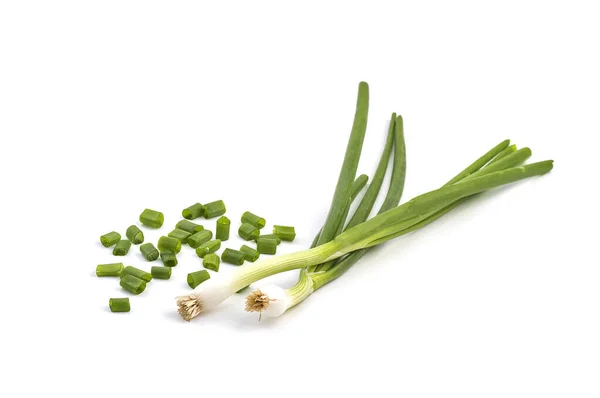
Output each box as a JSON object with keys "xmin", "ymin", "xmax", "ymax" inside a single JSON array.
[{"xmin": 0, "ymin": 1, "xmax": 600, "ymax": 397}]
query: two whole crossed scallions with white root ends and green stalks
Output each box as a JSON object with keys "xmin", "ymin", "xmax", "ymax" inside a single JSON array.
[{"xmin": 177, "ymin": 82, "xmax": 553, "ymax": 321}]
